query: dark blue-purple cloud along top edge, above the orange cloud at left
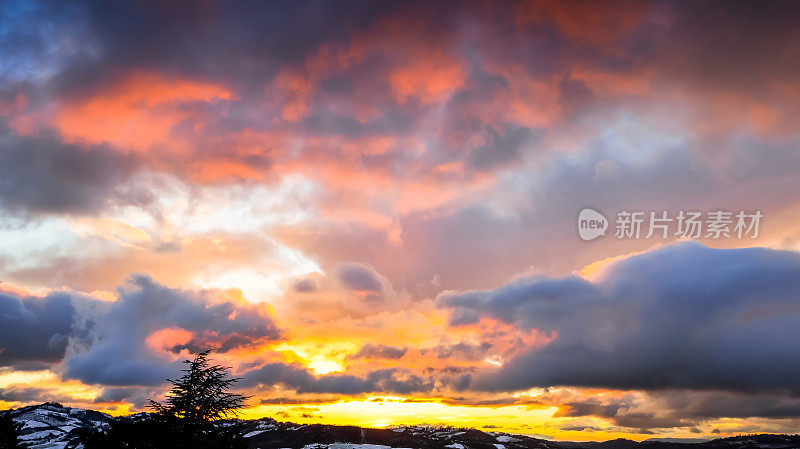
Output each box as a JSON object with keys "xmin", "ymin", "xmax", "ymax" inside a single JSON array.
[{"xmin": 19, "ymin": 0, "xmax": 394, "ymax": 94}]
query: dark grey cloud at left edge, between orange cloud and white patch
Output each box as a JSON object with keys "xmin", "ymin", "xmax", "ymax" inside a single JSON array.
[{"xmin": 0, "ymin": 119, "xmax": 142, "ymax": 214}]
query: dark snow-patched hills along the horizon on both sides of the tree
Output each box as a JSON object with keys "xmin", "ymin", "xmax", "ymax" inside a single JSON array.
[{"xmin": 6, "ymin": 403, "xmax": 800, "ymax": 449}]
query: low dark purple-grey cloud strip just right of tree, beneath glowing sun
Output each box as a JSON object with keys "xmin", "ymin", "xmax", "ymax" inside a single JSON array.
[{"xmin": 239, "ymin": 363, "xmax": 435, "ymax": 395}]
